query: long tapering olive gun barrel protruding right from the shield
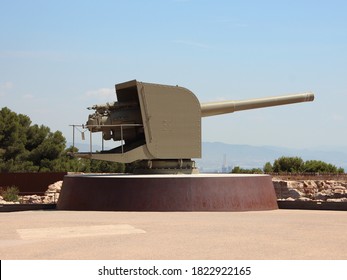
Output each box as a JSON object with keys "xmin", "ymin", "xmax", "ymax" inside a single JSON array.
[{"xmin": 201, "ymin": 93, "xmax": 314, "ymax": 117}]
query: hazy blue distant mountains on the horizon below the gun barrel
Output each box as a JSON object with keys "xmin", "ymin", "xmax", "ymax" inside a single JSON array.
[{"xmin": 196, "ymin": 142, "xmax": 347, "ymax": 172}]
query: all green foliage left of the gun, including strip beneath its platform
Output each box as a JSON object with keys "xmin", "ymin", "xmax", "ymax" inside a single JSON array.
[{"xmin": 0, "ymin": 107, "xmax": 125, "ymax": 173}]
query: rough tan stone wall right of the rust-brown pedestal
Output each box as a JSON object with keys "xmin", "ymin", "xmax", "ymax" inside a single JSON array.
[{"xmin": 272, "ymin": 178, "xmax": 347, "ymax": 202}]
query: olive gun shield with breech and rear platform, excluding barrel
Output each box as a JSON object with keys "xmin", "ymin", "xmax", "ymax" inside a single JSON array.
[{"xmin": 78, "ymin": 80, "xmax": 201, "ymax": 163}]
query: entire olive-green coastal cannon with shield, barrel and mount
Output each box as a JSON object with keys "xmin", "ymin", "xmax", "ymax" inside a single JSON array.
[{"xmin": 76, "ymin": 80, "xmax": 314, "ymax": 174}]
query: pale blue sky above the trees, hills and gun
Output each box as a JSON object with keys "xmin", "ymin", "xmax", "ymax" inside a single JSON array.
[{"xmin": 0, "ymin": 0, "xmax": 347, "ymax": 148}]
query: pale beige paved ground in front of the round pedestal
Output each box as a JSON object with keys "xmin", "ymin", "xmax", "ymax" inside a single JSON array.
[{"xmin": 0, "ymin": 210, "xmax": 347, "ymax": 260}]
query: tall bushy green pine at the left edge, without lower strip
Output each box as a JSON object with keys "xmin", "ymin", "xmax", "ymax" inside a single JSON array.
[{"xmin": 0, "ymin": 107, "xmax": 66, "ymax": 172}]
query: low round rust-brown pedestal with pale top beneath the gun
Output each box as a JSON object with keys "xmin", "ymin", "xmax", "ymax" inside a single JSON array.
[{"xmin": 57, "ymin": 174, "xmax": 278, "ymax": 211}]
